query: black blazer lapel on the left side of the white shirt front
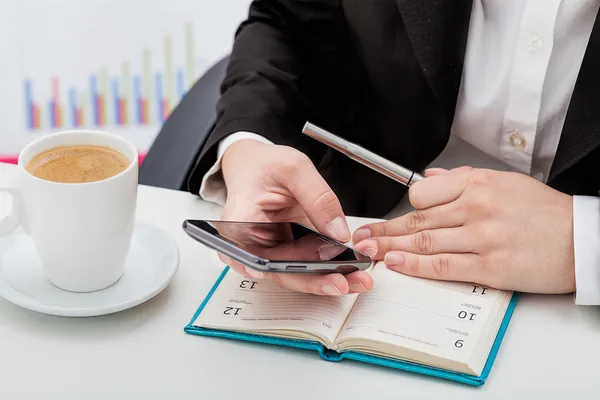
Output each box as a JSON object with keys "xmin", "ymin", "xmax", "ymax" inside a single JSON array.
[{"xmin": 396, "ymin": 0, "xmax": 473, "ymax": 124}]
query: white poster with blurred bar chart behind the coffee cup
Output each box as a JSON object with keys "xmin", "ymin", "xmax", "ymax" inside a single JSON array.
[{"xmin": 0, "ymin": 0, "xmax": 250, "ymax": 154}]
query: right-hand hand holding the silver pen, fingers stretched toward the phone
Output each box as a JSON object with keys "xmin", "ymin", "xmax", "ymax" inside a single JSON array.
[{"xmin": 353, "ymin": 168, "xmax": 575, "ymax": 293}]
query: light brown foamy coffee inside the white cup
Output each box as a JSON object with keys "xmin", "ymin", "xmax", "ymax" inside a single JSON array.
[{"xmin": 26, "ymin": 145, "xmax": 130, "ymax": 183}]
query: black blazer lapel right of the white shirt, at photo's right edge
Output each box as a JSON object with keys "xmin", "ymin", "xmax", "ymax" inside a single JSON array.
[{"xmin": 549, "ymin": 9, "xmax": 600, "ymax": 180}]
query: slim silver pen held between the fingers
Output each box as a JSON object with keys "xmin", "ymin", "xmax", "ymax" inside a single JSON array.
[{"xmin": 302, "ymin": 122, "xmax": 423, "ymax": 186}]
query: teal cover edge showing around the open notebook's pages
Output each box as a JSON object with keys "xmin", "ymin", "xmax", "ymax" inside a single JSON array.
[{"xmin": 184, "ymin": 267, "xmax": 518, "ymax": 386}]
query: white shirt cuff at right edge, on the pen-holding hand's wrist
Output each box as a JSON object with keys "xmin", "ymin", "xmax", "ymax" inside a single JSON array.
[{"xmin": 573, "ymin": 196, "xmax": 600, "ymax": 306}]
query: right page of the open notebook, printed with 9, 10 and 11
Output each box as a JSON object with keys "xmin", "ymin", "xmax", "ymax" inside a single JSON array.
[{"xmin": 338, "ymin": 264, "xmax": 507, "ymax": 363}]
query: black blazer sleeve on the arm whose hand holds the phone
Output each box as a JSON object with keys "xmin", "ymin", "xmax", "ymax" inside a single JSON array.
[{"xmin": 188, "ymin": 0, "xmax": 352, "ymax": 193}]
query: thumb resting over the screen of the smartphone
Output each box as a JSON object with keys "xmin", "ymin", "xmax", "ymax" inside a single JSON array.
[{"xmin": 282, "ymin": 158, "xmax": 350, "ymax": 243}]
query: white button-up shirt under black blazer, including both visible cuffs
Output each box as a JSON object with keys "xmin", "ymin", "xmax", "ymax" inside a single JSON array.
[{"xmin": 200, "ymin": 0, "xmax": 600, "ymax": 305}]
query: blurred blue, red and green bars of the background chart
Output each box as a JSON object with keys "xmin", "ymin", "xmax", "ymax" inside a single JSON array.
[{"xmin": 23, "ymin": 23, "xmax": 196, "ymax": 130}]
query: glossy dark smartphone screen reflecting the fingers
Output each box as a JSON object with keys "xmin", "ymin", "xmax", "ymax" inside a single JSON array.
[{"xmin": 191, "ymin": 221, "xmax": 370, "ymax": 263}]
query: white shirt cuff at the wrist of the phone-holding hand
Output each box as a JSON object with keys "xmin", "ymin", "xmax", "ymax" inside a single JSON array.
[{"xmin": 198, "ymin": 131, "xmax": 273, "ymax": 206}]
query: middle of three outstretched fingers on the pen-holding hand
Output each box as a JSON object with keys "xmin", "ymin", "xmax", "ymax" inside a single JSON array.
[{"xmin": 354, "ymin": 227, "xmax": 477, "ymax": 260}]
